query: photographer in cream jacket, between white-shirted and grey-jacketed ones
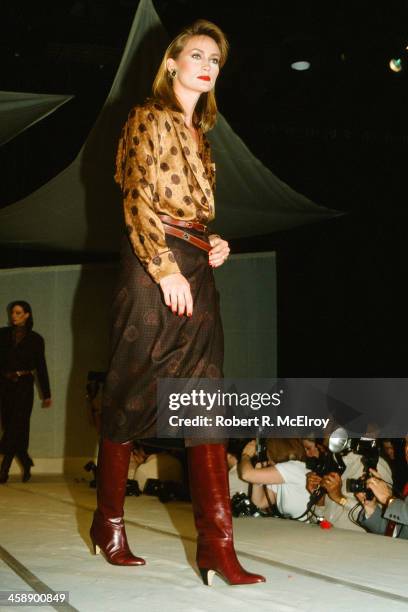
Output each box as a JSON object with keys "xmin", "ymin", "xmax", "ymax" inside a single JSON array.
[{"xmin": 306, "ymin": 444, "xmax": 392, "ymax": 531}]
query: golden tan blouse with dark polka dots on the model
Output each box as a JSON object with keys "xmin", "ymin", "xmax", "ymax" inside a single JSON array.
[{"xmin": 115, "ymin": 102, "xmax": 215, "ymax": 282}]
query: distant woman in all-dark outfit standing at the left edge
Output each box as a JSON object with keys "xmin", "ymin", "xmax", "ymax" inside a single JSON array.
[{"xmin": 0, "ymin": 301, "xmax": 51, "ymax": 483}]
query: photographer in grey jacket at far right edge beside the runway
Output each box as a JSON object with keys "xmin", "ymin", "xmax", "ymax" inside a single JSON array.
[{"xmin": 356, "ymin": 435, "xmax": 408, "ymax": 540}]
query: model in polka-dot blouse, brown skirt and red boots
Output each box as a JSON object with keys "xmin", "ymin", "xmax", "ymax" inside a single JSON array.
[{"xmin": 91, "ymin": 20, "xmax": 265, "ymax": 584}]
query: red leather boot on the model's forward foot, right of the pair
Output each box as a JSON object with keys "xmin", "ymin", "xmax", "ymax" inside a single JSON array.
[{"xmin": 188, "ymin": 444, "xmax": 265, "ymax": 585}]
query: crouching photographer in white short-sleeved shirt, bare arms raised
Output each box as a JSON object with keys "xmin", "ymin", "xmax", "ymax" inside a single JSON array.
[{"xmin": 239, "ymin": 438, "xmax": 309, "ymax": 520}]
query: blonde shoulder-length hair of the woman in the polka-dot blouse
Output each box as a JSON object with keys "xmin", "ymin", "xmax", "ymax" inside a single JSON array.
[{"xmin": 152, "ymin": 19, "xmax": 228, "ymax": 132}]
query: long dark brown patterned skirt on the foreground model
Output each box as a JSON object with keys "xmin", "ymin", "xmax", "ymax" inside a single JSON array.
[{"xmin": 102, "ymin": 235, "xmax": 224, "ymax": 442}]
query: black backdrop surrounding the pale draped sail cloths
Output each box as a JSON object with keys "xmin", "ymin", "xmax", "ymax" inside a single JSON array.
[{"xmin": 0, "ymin": 0, "xmax": 408, "ymax": 376}]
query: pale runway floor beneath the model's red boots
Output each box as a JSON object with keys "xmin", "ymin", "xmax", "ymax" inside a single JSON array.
[{"xmin": 0, "ymin": 476, "xmax": 408, "ymax": 612}]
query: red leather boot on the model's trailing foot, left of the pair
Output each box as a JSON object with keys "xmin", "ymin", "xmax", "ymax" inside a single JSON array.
[{"xmin": 90, "ymin": 439, "xmax": 145, "ymax": 565}]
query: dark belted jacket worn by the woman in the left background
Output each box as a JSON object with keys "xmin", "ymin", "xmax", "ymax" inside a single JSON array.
[{"xmin": 0, "ymin": 327, "xmax": 51, "ymax": 399}]
